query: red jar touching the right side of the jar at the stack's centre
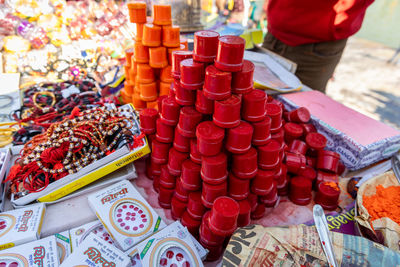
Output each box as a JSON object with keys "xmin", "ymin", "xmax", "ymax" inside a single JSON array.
[{"xmin": 225, "ymin": 121, "xmax": 253, "ymax": 154}]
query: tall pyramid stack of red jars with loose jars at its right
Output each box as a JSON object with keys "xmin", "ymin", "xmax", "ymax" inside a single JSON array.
[{"xmin": 140, "ymin": 31, "xmax": 338, "ymax": 260}]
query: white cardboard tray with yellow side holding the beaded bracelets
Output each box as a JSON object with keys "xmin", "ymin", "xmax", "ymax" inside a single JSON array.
[{"xmin": 11, "ymin": 105, "xmax": 150, "ymax": 206}]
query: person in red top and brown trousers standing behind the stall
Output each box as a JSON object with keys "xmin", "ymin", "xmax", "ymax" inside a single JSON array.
[{"xmin": 263, "ymin": 0, "xmax": 374, "ymax": 92}]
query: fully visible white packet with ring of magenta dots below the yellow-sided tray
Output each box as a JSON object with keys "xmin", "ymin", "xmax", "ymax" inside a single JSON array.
[{"xmin": 88, "ymin": 180, "xmax": 165, "ymax": 251}]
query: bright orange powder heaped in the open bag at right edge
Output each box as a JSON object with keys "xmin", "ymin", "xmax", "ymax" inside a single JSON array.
[{"xmin": 363, "ymin": 185, "xmax": 400, "ymax": 225}]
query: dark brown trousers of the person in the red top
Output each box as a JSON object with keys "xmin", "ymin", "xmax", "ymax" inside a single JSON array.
[{"xmin": 263, "ymin": 33, "xmax": 347, "ymax": 93}]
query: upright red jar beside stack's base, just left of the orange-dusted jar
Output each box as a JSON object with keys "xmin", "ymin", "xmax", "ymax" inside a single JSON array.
[{"xmin": 289, "ymin": 176, "xmax": 312, "ymax": 206}]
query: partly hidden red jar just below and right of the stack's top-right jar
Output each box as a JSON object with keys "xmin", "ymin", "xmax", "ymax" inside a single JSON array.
[{"xmin": 232, "ymin": 59, "xmax": 255, "ymax": 94}]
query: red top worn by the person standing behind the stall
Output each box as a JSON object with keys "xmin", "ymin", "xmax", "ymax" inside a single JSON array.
[{"xmin": 267, "ymin": 0, "xmax": 374, "ymax": 46}]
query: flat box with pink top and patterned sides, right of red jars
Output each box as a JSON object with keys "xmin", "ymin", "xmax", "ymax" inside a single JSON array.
[{"xmin": 278, "ymin": 91, "xmax": 400, "ymax": 170}]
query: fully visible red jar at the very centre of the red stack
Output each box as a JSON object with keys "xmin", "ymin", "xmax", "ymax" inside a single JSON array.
[{"xmin": 196, "ymin": 121, "xmax": 225, "ymax": 156}]
